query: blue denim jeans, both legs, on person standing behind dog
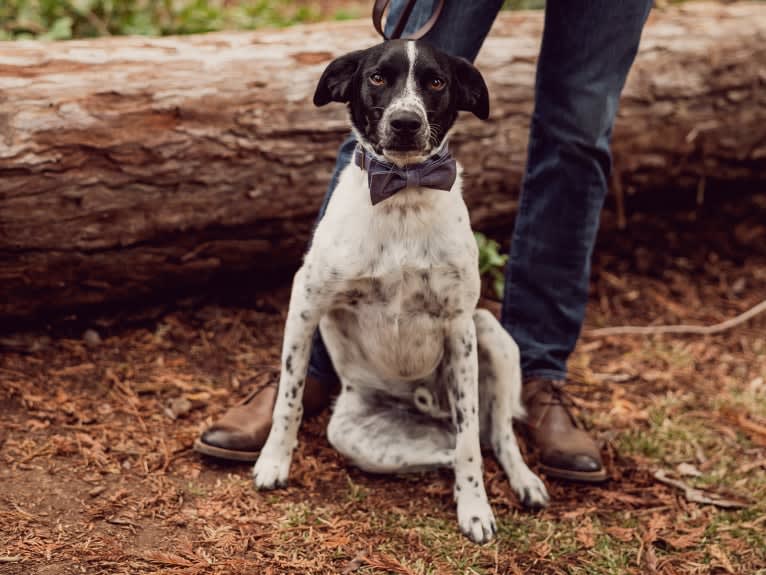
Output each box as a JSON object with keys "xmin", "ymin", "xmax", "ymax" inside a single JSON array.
[{"xmin": 309, "ymin": 0, "xmax": 652, "ymax": 383}]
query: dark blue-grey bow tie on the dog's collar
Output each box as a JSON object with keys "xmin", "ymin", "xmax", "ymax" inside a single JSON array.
[{"xmin": 354, "ymin": 146, "xmax": 457, "ymax": 206}]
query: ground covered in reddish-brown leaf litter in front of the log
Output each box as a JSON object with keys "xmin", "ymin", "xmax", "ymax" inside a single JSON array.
[{"xmin": 0, "ymin": 191, "xmax": 766, "ymax": 575}]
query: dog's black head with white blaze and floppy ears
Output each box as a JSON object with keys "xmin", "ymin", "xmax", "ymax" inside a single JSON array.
[{"xmin": 314, "ymin": 40, "xmax": 489, "ymax": 164}]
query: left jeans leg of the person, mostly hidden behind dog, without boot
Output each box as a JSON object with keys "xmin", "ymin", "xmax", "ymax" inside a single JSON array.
[{"xmin": 309, "ymin": 0, "xmax": 503, "ymax": 386}]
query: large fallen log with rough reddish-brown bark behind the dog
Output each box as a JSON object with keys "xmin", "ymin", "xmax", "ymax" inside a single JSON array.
[{"xmin": 0, "ymin": 3, "xmax": 766, "ymax": 319}]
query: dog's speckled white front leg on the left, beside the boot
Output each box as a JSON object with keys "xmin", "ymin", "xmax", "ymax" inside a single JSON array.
[{"xmin": 253, "ymin": 265, "xmax": 322, "ymax": 489}]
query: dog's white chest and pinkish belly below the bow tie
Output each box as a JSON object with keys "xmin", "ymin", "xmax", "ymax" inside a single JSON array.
[{"xmin": 314, "ymin": 176, "xmax": 480, "ymax": 381}]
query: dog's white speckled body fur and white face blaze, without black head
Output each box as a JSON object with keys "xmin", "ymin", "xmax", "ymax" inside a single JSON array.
[{"xmin": 253, "ymin": 43, "xmax": 548, "ymax": 543}]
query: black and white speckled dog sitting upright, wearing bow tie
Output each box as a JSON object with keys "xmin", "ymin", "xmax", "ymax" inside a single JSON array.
[{"xmin": 253, "ymin": 40, "xmax": 548, "ymax": 543}]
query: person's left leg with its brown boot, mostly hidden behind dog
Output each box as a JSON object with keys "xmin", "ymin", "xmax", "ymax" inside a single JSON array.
[{"xmin": 194, "ymin": 0, "xmax": 502, "ymax": 461}]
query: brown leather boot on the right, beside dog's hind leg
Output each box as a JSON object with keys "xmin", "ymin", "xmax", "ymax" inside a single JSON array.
[{"xmin": 521, "ymin": 378, "xmax": 607, "ymax": 483}]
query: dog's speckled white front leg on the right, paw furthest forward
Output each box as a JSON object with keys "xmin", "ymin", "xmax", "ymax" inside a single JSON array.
[{"xmin": 445, "ymin": 315, "xmax": 497, "ymax": 543}]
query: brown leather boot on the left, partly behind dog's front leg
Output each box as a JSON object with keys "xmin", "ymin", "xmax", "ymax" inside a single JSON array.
[{"xmin": 194, "ymin": 377, "xmax": 332, "ymax": 461}]
